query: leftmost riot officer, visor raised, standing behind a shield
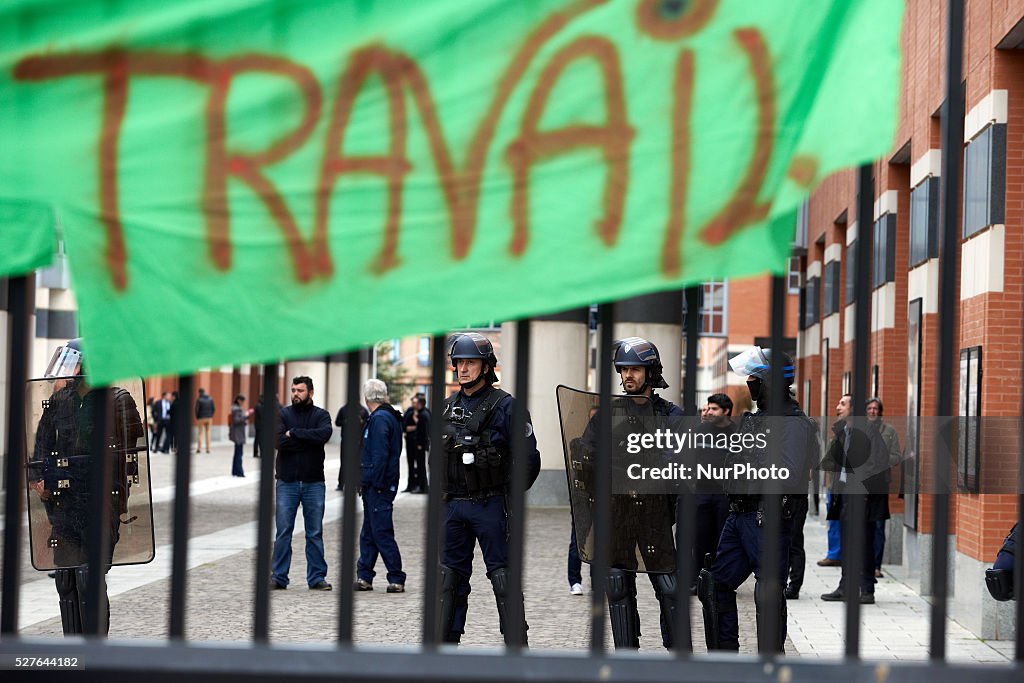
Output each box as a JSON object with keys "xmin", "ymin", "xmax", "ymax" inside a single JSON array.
[{"xmin": 28, "ymin": 339, "xmax": 145, "ymax": 635}]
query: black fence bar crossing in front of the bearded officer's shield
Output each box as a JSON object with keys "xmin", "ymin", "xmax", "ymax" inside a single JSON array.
[{"xmin": 590, "ymin": 302, "xmax": 615, "ymax": 656}]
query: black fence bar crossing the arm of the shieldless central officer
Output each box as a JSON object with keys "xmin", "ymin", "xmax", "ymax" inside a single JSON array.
[{"xmin": 505, "ymin": 318, "xmax": 530, "ymax": 652}]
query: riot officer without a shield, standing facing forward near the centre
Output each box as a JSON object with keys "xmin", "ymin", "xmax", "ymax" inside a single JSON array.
[{"xmin": 439, "ymin": 332, "xmax": 541, "ymax": 645}]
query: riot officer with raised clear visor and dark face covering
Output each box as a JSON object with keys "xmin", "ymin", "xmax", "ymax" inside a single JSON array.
[{"xmin": 697, "ymin": 346, "xmax": 816, "ymax": 652}]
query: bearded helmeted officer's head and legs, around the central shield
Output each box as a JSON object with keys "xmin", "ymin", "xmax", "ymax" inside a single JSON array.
[{"xmin": 607, "ymin": 337, "xmax": 683, "ymax": 649}]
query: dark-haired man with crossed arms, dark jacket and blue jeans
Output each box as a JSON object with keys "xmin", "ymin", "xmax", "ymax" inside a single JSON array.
[{"xmin": 270, "ymin": 377, "xmax": 333, "ymax": 591}]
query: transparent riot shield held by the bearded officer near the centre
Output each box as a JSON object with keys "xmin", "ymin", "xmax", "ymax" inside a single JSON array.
[{"xmin": 556, "ymin": 386, "xmax": 677, "ymax": 573}]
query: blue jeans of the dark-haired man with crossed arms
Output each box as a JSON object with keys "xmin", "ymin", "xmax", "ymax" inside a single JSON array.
[{"xmin": 270, "ymin": 480, "xmax": 327, "ymax": 586}]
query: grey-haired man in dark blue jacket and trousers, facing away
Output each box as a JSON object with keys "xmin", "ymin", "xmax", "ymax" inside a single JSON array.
[{"xmin": 354, "ymin": 379, "xmax": 406, "ymax": 593}]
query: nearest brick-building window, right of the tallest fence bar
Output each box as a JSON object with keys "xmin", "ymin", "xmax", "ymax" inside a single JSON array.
[{"xmin": 964, "ymin": 124, "xmax": 1007, "ymax": 238}]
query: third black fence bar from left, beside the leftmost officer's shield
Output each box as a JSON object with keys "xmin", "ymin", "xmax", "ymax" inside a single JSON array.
[{"xmin": 170, "ymin": 375, "xmax": 194, "ymax": 638}]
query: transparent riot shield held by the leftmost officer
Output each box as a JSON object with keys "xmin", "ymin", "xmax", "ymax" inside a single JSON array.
[{"xmin": 25, "ymin": 377, "xmax": 155, "ymax": 570}]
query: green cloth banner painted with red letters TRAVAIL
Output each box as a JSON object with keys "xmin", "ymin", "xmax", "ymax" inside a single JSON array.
[{"xmin": 0, "ymin": 0, "xmax": 903, "ymax": 381}]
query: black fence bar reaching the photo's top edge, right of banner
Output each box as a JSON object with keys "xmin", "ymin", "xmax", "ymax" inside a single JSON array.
[{"xmin": 929, "ymin": 0, "xmax": 964, "ymax": 660}]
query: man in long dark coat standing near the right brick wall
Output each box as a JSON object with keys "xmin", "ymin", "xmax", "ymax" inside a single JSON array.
[{"xmin": 820, "ymin": 394, "xmax": 889, "ymax": 604}]
